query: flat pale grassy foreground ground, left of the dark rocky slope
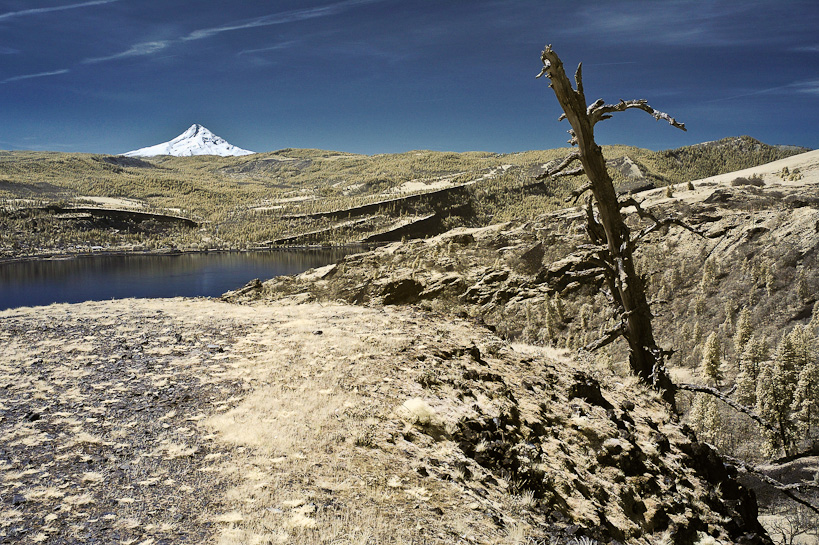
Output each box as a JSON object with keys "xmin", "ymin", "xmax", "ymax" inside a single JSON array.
[{"xmin": 0, "ymin": 298, "xmax": 552, "ymax": 545}]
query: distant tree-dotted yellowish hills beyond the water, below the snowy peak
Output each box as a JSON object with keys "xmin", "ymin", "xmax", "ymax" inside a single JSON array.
[{"xmin": 0, "ymin": 135, "xmax": 802, "ymax": 256}]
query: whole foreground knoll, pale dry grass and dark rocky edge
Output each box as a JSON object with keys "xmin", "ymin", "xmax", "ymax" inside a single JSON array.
[{"xmin": 0, "ymin": 296, "xmax": 770, "ymax": 545}]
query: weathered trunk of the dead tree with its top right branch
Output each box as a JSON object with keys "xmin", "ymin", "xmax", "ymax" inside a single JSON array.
[{"xmin": 538, "ymin": 46, "xmax": 685, "ymax": 408}]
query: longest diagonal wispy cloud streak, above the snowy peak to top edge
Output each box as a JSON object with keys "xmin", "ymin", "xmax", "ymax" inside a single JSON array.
[{"xmin": 82, "ymin": 0, "xmax": 383, "ymax": 64}]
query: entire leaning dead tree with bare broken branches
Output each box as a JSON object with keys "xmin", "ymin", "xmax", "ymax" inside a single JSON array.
[{"xmin": 537, "ymin": 46, "xmax": 685, "ymax": 408}]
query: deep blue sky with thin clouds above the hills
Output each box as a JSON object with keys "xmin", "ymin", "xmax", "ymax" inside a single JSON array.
[{"xmin": 0, "ymin": 0, "xmax": 819, "ymax": 154}]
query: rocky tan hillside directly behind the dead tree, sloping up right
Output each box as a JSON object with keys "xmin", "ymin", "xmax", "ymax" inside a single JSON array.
[{"xmin": 226, "ymin": 148, "xmax": 819, "ymax": 536}]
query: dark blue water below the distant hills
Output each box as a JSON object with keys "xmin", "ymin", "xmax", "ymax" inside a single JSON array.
[{"xmin": 0, "ymin": 247, "xmax": 362, "ymax": 310}]
